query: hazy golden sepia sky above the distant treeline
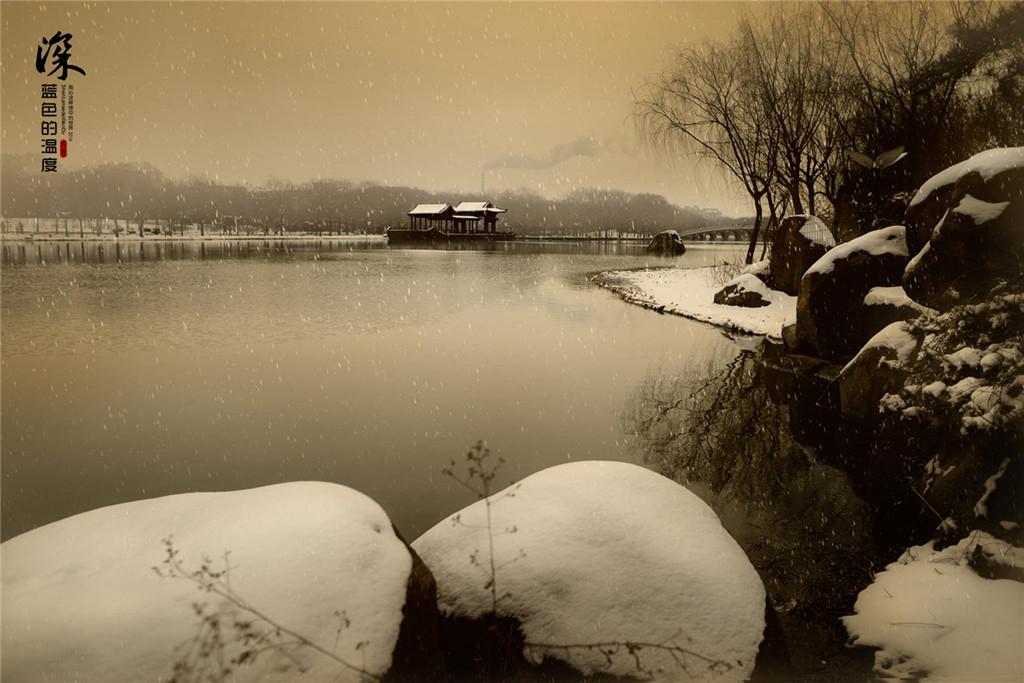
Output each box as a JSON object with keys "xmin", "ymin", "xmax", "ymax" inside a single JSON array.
[{"xmin": 0, "ymin": 1, "xmax": 753, "ymax": 215}]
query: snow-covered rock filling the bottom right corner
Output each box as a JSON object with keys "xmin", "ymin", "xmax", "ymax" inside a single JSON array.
[{"xmin": 843, "ymin": 531, "xmax": 1024, "ymax": 681}]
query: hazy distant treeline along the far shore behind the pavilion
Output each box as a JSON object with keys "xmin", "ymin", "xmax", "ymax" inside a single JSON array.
[{"xmin": 0, "ymin": 155, "xmax": 737, "ymax": 234}]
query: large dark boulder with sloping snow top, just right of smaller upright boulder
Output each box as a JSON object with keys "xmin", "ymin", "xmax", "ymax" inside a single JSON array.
[{"xmin": 796, "ymin": 225, "xmax": 907, "ymax": 360}]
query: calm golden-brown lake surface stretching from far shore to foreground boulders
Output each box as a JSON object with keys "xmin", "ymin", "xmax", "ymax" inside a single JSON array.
[{"xmin": 0, "ymin": 237, "xmax": 741, "ymax": 540}]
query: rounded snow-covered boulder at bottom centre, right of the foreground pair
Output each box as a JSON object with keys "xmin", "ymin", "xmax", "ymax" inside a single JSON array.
[{"xmin": 413, "ymin": 462, "xmax": 765, "ymax": 681}]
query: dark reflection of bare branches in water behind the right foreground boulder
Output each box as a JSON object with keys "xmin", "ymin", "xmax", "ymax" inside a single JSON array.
[{"xmin": 623, "ymin": 351, "xmax": 869, "ymax": 651}]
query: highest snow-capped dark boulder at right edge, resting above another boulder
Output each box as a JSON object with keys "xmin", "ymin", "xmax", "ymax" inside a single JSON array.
[{"xmin": 904, "ymin": 147, "xmax": 1024, "ymax": 256}]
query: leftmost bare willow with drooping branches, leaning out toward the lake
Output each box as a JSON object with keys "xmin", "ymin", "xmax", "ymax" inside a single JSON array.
[{"xmin": 634, "ymin": 41, "xmax": 778, "ymax": 263}]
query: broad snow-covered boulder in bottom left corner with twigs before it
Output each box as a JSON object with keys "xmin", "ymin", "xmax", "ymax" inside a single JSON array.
[{"xmin": 0, "ymin": 482, "xmax": 413, "ymax": 683}]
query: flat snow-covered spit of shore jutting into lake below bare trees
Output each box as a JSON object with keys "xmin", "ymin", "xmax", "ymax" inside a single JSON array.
[{"xmin": 592, "ymin": 266, "xmax": 797, "ymax": 337}]
